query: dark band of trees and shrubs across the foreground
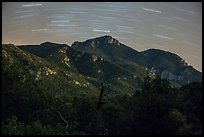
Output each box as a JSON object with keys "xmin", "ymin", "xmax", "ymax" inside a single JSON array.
[{"xmin": 2, "ymin": 63, "xmax": 202, "ymax": 135}]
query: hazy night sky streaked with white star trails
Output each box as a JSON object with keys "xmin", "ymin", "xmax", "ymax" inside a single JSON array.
[{"xmin": 2, "ymin": 2, "xmax": 202, "ymax": 71}]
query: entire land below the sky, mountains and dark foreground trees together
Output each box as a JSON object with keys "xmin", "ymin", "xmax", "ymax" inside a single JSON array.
[{"xmin": 2, "ymin": 36, "xmax": 202, "ymax": 135}]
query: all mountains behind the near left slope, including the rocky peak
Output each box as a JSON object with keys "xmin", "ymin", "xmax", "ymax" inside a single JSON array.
[{"xmin": 2, "ymin": 36, "xmax": 202, "ymax": 91}]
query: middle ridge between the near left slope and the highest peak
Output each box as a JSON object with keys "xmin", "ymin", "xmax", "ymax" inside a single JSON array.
[{"xmin": 19, "ymin": 40, "xmax": 143, "ymax": 93}]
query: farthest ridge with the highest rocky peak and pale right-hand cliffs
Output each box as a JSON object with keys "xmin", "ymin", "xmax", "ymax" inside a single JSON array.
[{"xmin": 71, "ymin": 36, "xmax": 202, "ymax": 84}]
